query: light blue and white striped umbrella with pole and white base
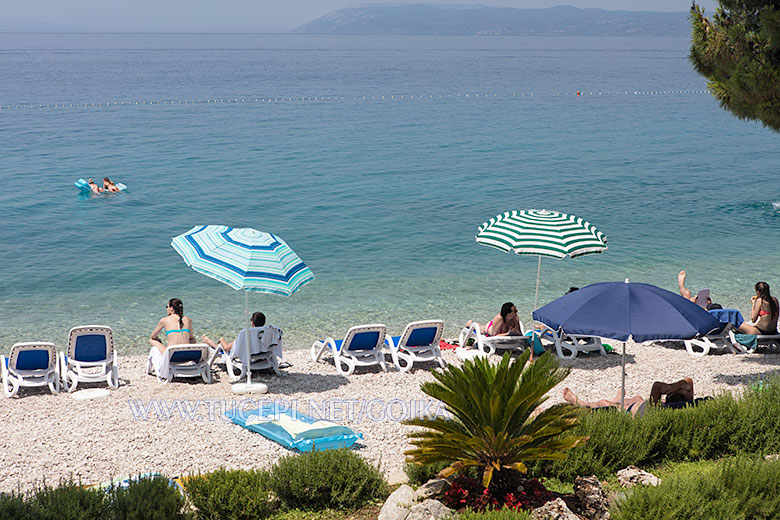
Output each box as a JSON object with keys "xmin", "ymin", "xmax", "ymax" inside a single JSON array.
[{"xmin": 171, "ymin": 226, "xmax": 314, "ymax": 393}]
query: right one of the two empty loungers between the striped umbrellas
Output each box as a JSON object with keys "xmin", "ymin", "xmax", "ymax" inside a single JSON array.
[{"xmin": 385, "ymin": 320, "xmax": 447, "ymax": 372}]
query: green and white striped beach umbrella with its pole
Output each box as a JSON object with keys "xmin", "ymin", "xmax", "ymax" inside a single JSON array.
[{"xmin": 476, "ymin": 209, "xmax": 607, "ymax": 348}]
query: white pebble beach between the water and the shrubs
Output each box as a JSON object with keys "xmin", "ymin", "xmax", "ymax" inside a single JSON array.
[{"xmin": 0, "ymin": 342, "xmax": 780, "ymax": 492}]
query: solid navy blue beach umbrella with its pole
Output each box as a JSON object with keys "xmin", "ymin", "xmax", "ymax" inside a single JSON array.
[{"xmin": 533, "ymin": 280, "xmax": 721, "ymax": 408}]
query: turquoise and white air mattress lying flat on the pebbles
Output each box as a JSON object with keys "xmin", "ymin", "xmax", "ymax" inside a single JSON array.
[{"xmin": 225, "ymin": 403, "xmax": 363, "ymax": 452}]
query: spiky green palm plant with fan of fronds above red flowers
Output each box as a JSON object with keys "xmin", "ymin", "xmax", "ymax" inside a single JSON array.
[{"xmin": 405, "ymin": 350, "xmax": 587, "ymax": 488}]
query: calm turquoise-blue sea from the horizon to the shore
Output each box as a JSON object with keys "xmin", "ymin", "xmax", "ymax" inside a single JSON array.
[{"xmin": 0, "ymin": 34, "xmax": 780, "ymax": 352}]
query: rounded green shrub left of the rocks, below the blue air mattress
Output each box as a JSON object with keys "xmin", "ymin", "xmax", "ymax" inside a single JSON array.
[{"xmin": 271, "ymin": 448, "xmax": 388, "ymax": 509}]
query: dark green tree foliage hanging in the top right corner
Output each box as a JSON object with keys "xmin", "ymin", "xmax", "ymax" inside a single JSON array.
[{"xmin": 690, "ymin": 0, "xmax": 780, "ymax": 132}]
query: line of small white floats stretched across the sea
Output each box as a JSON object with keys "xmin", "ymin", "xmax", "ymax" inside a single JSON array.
[{"xmin": 0, "ymin": 90, "xmax": 709, "ymax": 110}]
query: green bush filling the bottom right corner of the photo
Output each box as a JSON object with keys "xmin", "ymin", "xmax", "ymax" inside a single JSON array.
[{"xmin": 611, "ymin": 457, "xmax": 780, "ymax": 520}]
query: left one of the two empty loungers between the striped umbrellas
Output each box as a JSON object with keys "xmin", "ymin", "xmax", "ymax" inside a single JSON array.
[{"xmin": 311, "ymin": 324, "xmax": 387, "ymax": 376}]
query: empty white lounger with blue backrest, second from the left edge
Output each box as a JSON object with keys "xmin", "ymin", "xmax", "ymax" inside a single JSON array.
[{"xmin": 60, "ymin": 325, "xmax": 119, "ymax": 392}]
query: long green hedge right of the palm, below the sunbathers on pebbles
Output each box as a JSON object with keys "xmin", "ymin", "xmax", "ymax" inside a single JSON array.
[{"xmin": 530, "ymin": 378, "xmax": 780, "ymax": 481}]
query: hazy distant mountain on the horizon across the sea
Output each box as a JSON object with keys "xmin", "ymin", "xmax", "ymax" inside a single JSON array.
[{"xmin": 292, "ymin": 4, "xmax": 691, "ymax": 36}]
